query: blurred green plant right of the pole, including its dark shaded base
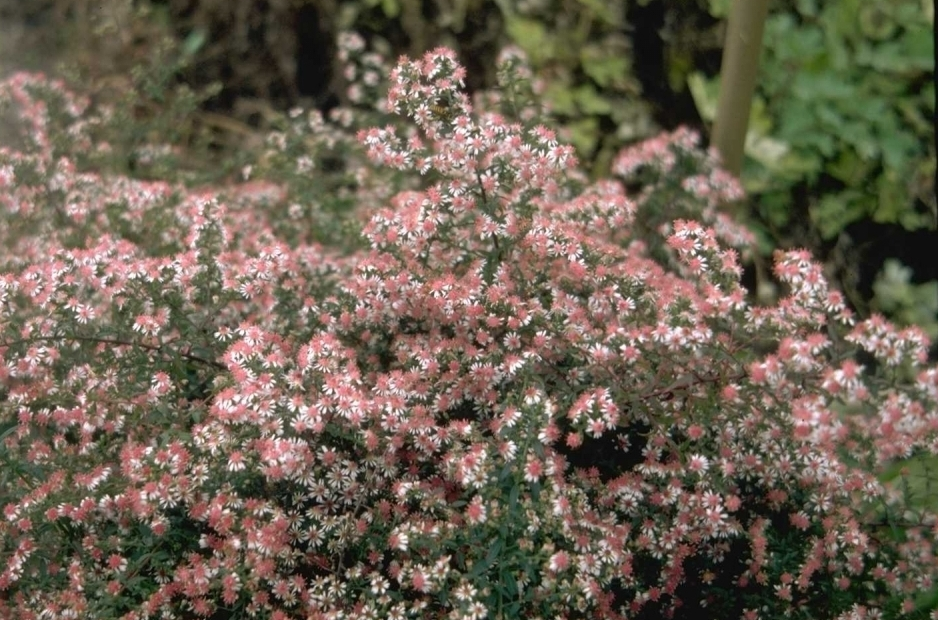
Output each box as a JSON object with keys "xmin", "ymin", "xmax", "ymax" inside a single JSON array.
[{"xmin": 688, "ymin": 0, "xmax": 938, "ymax": 334}]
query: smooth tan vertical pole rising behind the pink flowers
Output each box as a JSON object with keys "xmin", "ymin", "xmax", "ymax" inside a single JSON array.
[{"xmin": 711, "ymin": 0, "xmax": 769, "ymax": 177}]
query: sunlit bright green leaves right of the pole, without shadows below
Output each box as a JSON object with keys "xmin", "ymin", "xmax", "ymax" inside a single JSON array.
[{"xmin": 697, "ymin": 0, "xmax": 936, "ymax": 239}]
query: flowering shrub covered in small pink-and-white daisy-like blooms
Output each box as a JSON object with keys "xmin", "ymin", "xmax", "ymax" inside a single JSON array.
[{"xmin": 0, "ymin": 44, "xmax": 938, "ymax": 620}]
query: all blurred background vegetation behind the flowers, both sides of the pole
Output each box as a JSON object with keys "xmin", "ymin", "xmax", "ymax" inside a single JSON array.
[{"xmin": 0, "ymin": 0, "xmax": 938, "ymax": 342}]
